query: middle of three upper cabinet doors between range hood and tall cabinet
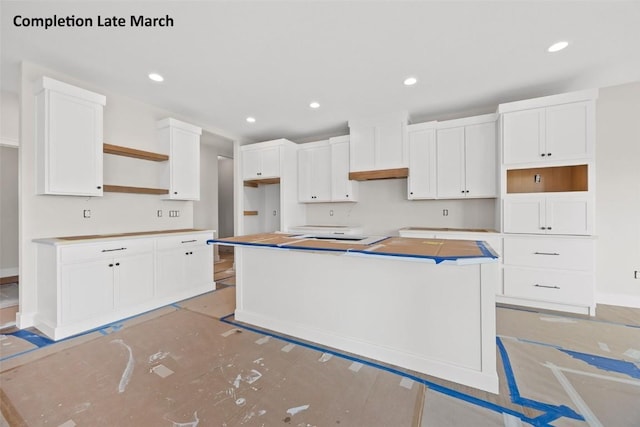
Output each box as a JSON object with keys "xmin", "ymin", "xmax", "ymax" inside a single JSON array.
[{"xmin": 437, "ymin": 127, "xmax": 465, "ymax": 199}]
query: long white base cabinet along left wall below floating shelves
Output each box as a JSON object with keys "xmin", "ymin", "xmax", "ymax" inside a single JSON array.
[{"xmin": 35, "ymin": 231, "xmax": 215, "ymax": 340}]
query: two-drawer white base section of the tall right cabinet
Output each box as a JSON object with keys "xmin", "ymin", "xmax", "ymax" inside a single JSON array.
[{"xmin": 498, "ymin": 236, "xmax": 595, "ymax": 315}]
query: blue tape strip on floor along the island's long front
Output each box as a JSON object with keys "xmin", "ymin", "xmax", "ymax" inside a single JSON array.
[{"xmin": 220, "ymin": 314, "xmax": 540, "ymax": 427}]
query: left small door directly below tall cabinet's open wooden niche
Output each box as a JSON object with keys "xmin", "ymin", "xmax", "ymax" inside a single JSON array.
[{"xmin": 503, "ymin": 197, "xmax": 545, "ymax": 234}]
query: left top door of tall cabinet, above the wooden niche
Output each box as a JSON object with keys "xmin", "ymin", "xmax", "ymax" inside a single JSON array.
[{"xmin": 502, "ymin": 108, "xmax": 546, "ymax": 164}]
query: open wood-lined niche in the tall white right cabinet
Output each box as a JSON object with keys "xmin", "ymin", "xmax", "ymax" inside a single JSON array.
[{"xmin": 507, "ymin": 165, "xmax": 589, "ymax": 193}]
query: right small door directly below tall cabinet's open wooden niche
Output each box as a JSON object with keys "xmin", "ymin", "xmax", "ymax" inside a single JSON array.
[{"xmin": 546, "ymin": 195, "xmax": 593, "ymax": 235}]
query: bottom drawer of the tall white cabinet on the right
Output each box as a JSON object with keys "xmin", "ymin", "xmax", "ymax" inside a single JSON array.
[{"xmin": 504, "ymin": 266, "xmax": 594, "ymax": 306}]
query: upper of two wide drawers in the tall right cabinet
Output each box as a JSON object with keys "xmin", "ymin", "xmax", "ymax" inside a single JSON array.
[{"xmin": 504, "ymin": 237, "xmax": 595, "ymax": 271}]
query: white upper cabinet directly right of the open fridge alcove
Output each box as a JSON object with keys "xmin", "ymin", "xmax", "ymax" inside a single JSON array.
[{"xmin": 298, "ymin": 141, "xmax": 331, "ymax": 203}]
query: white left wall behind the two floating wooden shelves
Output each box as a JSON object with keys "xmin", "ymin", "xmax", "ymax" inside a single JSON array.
[{"xmin": 18, "ymin": 63, "xmax": 200, "ymax": 328}]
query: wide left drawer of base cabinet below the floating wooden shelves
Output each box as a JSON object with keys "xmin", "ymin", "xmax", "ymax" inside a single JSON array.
[{"xmin": 60, "ymin": 239, "xmax": 153, "ymax": 264}]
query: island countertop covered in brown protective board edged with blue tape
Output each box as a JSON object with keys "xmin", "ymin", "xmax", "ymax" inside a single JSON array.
[{"xmin": 207, "ymin": 233, "xmax": 497, "ymax": 264}]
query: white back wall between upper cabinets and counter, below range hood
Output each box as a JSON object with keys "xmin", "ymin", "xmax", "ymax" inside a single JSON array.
[{"xmin": 307, "ymin": 179, "xmax": 497, "ymax": 235}]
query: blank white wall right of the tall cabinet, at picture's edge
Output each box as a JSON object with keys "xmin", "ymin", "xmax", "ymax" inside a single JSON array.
[{"xmin": 596, "ymin": 82, "xmax": 640, "ymax": 307}]
